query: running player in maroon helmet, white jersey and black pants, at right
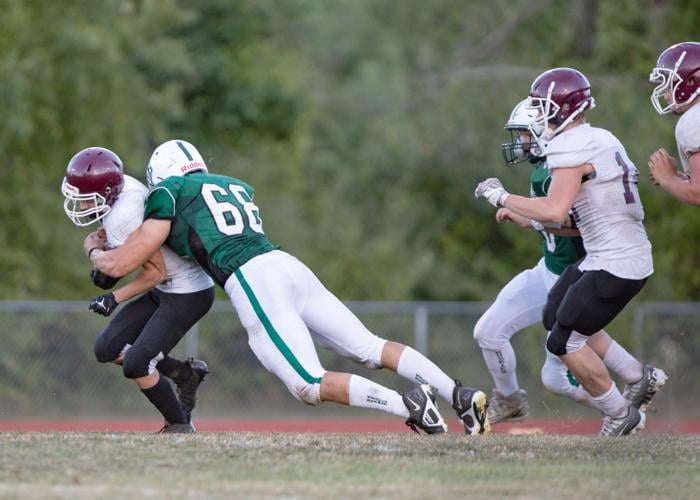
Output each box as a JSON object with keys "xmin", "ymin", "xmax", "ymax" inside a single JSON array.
[{"xmin": 475, "ymin": 68, "xmax": 665, "ymax": 436}]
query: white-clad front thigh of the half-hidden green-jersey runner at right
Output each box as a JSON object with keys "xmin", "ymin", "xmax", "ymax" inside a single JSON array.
[{"xmin": 474, "ymin": 262, "xmax": 547, "ymax": 339}]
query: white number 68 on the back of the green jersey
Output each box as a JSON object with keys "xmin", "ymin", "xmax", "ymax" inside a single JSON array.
[{"xmin": 202, "ymin": 184, "xmax": 263, "ymax": 236}]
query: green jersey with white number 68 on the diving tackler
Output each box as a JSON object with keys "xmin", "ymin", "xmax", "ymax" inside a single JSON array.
[{"xmin": 144, "ymin": 172, "xmax": 279, "ymax": 287}]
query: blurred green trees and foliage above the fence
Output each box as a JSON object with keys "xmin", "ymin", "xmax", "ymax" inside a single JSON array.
[{"xmin": 0, "ymin": 0, "xmax": 700, "ymax": 300}]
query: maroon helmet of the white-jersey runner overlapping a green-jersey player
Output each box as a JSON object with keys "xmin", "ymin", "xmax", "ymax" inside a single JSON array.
[{"xmin": 529, "ymin": 68, "xmax": 595, "ymax": 140}]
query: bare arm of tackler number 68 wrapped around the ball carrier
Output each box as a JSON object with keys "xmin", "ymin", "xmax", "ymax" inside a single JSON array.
[{"xmin": 85, "ymin": 219, "xmax": 172, "ymax": 277}]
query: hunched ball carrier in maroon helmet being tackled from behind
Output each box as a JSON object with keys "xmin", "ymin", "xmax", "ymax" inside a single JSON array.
[{"xmin": 61, "ymin": 147, "xmax": 214, "ymax": 433}]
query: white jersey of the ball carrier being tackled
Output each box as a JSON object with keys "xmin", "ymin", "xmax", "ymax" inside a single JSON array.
[{"xmin": 102, "ymin": 175, "xmax": 214, "ymax": 293}]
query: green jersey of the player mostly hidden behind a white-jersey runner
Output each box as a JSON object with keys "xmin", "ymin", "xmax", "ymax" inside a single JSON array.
[{"xmin": 530, "ymin": 161, "xmax": 585, "ymax": 274}]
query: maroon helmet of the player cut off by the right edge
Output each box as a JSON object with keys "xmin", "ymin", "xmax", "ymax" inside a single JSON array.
[{"xmin": 649, "ymin": 42, "xmax": 700, "ymax": 115}]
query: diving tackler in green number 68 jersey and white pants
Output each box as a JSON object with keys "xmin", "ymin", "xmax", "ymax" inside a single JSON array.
[{"xmin": 87, "ymin": 140, "xmax": 489, "ymax": 434}]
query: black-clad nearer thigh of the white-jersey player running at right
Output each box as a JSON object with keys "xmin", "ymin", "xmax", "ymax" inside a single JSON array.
[{"xmin": 556, "ymin": 271, "xmax": 646, "ymax": 336}]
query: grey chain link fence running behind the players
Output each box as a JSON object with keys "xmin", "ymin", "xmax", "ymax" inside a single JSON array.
[{"xmin": 0, "ymin": 301, "xmax": 700, "ymax": 420}]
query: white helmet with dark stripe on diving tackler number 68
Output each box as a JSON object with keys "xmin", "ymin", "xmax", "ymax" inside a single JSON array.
[{"xmin": 146, "ymin": 139, "xmax": 208, "ymax": 189}]
